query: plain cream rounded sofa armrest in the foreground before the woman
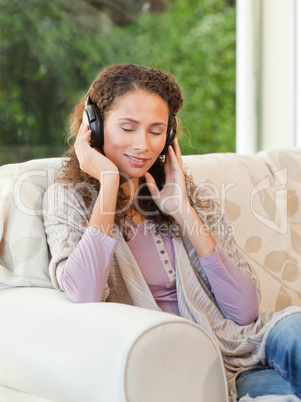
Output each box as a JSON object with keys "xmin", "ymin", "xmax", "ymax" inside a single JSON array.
[{"xmin": 0, "ymin": 288, "xmax": 227, "ymax": 402}]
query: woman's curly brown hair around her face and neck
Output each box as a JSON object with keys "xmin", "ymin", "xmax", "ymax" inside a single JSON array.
[{"xmin": 57, "ymin": 64, "xmax": 183, "ymax": 237}]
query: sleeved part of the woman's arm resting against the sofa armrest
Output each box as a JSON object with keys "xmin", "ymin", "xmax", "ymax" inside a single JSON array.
[{"xmin": 43, "ymin": 183, "xmax": 117, "ymax": 302}]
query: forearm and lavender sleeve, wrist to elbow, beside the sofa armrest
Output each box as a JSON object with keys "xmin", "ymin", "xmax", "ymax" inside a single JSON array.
[{"xmin": 61, "ymin": 175, "xmax": 118, "ymax": 303}]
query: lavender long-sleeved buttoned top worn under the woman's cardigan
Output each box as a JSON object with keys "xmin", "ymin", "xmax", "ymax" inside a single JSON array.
[{"xmin": 61, "ymin": 220, "xmax": 258, "ymax": 325}]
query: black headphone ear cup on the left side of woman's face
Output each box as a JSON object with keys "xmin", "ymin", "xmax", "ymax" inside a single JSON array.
[{"xmin": 83, "ymin": 104, "xmax": 104, "ymax": 150}]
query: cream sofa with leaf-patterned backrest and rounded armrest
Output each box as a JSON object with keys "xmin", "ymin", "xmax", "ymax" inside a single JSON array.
[{"xmin": 0, "ymin": 149, "xmax": 301, "ymax": 402}]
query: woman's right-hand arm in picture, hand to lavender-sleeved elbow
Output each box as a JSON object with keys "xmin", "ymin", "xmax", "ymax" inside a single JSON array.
[{"xmin": 146, "ymin": 141, "xmax": 258, "ymax": 325}]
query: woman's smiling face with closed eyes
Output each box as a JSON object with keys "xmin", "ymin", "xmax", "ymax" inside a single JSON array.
[{"xmin": 103, "ymin": 90, "xmax": 169, "ymax": 178}]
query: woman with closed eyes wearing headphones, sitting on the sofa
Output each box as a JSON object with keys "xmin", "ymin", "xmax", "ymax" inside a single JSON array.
[{"xmin": 44, "ymin": 64, "xmax": 301, "ymax": 400}]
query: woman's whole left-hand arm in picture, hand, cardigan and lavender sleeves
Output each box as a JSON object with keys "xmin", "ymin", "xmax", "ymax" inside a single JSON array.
[{"xmin": 44, "ymin": 125, "xmax": 119, "ymax": 302}]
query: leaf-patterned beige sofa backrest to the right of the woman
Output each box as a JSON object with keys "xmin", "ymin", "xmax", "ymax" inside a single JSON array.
[{"xmin": 183, "ymin": 148, "xmax": 301, "ymax": 311}]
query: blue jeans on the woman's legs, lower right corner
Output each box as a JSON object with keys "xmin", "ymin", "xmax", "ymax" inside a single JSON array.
[{"xmin": 236, "ymin": 313, "xmax": 301, "ymax": 398}]
